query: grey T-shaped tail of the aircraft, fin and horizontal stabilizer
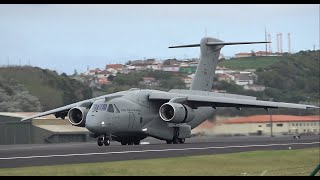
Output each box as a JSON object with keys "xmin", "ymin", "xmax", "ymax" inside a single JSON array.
[{"xmin": 169, "ymin": 37, "xmax": 270, "ymax": 91}]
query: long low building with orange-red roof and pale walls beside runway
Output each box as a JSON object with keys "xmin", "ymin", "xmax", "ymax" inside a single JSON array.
[{"xmin": 212, "ymin": 115, "xmax": 320, "ymax": 136}]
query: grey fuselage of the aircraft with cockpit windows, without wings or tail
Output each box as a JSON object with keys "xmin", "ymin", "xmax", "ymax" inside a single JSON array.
[{"xmin": 85, "ymin": 89, "xmax": 214, "ymax": 140}]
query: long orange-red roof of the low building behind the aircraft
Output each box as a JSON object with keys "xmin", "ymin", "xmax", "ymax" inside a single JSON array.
[{"xmin": 223, "ymin": 115, "xmax": 320, "ymax": 124}]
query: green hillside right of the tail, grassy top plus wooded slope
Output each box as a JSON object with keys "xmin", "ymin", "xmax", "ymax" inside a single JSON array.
[{"xmin": 219, "ymin": 50, "xmax": 320, "ymax": 103}]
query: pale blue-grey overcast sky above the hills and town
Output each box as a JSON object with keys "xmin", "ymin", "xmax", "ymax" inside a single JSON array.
[{"xmin": 0, "ymin": 4, "xmax": 320, "ymax": 74}]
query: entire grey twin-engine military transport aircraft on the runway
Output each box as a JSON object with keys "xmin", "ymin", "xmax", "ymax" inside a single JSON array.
[{"xmin": 22, "ymin": 37, "xmax": 318, "ymax": 146}]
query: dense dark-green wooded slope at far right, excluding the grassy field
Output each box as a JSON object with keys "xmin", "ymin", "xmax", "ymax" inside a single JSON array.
[{"xmin": 257, "ymin": 51, "xmax": 320, "ymax": 103}]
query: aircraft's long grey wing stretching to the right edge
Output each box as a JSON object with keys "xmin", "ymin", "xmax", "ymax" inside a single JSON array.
[{"xmin": 149, "ymin": 90, "xmax": 319, "ymax": 109}]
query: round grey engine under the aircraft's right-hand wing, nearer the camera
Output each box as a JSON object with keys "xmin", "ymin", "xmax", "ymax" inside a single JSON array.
[{"xmin": 159, "ymin": 102, "xmax": 195, "ymax": 123}]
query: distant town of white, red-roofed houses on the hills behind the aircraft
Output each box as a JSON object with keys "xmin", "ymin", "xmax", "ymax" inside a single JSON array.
[{"xmin": 73, "ymin": 51, "xmax": 283, "ymax": 91}]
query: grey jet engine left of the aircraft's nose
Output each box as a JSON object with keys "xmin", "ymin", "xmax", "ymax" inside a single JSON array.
[{"xmin": 68, "ymin": 107, "xmax": 89, "ymax": 127}]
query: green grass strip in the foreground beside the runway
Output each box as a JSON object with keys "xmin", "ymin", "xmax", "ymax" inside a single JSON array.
[{"xmin": 0, "ymin": 148, "xmax": 320, "ymax": 176}]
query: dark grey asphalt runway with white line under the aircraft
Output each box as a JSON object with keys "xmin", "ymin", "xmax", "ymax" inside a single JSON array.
[{"xmin": 0, "ymin": 135, "xmax": 320, "ymax": 168}]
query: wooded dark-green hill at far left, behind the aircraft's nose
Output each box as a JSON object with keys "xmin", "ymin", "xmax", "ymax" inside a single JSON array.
[{"xmin": 0, "ymin": 66, "xmax": 92, "ymax": 111}]
